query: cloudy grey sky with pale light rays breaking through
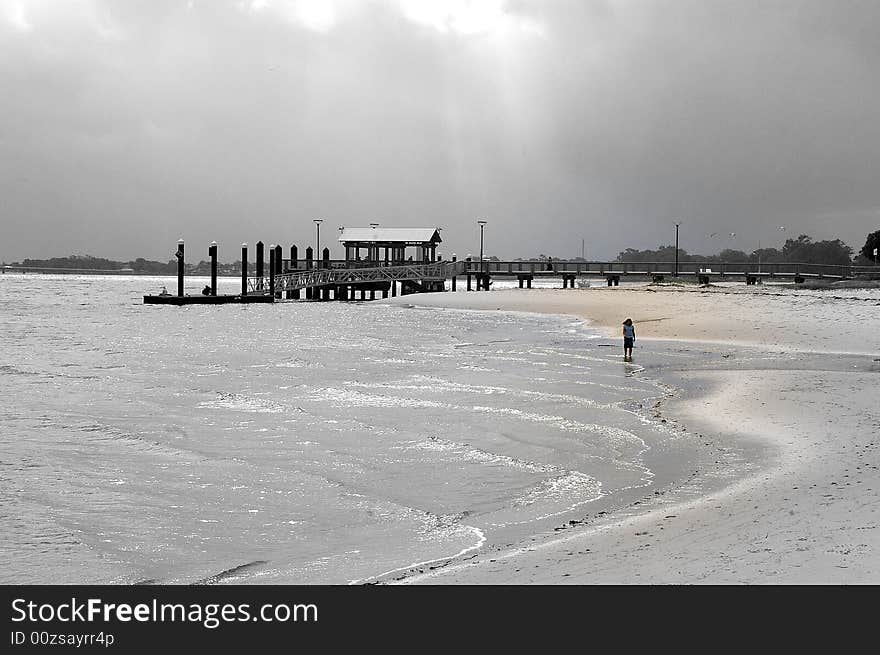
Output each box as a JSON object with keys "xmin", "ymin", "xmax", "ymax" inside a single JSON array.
[{"xmin": 0, "ymin": 0, "xmax": 880, "ymax": 262}]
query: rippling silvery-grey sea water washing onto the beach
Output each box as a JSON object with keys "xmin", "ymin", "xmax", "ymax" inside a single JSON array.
[{"xmin": 0, "ymin": 275, "xmax": 698, "ymax": 584}]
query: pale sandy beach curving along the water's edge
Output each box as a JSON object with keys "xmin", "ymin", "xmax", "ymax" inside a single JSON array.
[{"xmin": 385, "ymin": 285, "xmax": 880, "ymax": 584}]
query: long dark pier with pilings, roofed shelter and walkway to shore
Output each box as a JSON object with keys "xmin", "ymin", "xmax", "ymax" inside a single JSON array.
[{"xmin": 144, "ymin": 225, "xmax": 871, "ymax": 305}]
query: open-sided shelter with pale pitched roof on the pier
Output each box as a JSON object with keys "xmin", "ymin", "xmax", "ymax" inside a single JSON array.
[{"xmin": 339, "ymin": 226, "xmax": 443, "ymax": 266}]
